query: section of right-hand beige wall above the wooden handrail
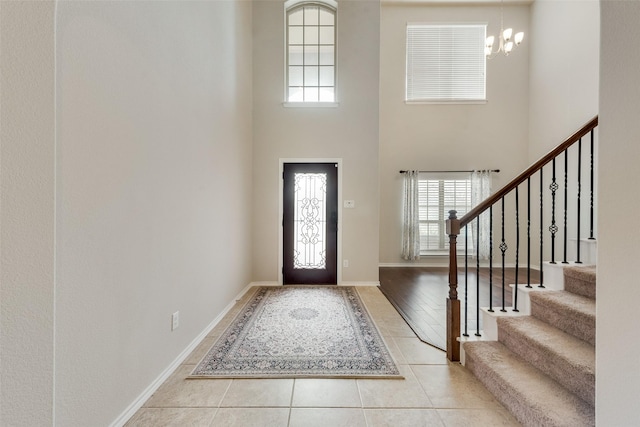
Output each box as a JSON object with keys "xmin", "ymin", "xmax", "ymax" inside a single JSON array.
[{"xmin": 529, "ymin": 0, "xmax": 600, "ymax": 163}]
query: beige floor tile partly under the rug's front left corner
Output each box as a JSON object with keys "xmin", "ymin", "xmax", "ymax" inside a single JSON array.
[{"xmin": 144, "ymin": 365, "xmax": 231, "ymax": 408}]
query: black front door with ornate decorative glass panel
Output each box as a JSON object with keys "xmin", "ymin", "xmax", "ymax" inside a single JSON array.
[{"xmin": 282, "ymin": 163, "xmax": 338, "ymax": 285}]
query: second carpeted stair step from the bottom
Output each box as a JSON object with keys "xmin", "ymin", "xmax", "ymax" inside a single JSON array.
[{"xmin": 498, "ymin": 316, "xmax": 596, "ymax": 405}]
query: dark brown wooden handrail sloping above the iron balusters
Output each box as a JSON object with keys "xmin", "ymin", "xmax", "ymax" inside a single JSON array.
[{"xmin": 460, "ymin": 116, "xmax": 598, "ymax": 228}]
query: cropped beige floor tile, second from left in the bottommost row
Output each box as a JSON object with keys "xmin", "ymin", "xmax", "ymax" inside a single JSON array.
[{"xmin": 210, "ymin": 408, "xmax": 289, "ymax": 427}]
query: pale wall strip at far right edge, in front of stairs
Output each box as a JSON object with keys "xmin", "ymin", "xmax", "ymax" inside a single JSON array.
[{"xmin": 596, "ymin": 1, "xmax": 640, "ymax": 426}]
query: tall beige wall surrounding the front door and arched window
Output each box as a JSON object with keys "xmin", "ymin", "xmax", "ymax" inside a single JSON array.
[{"xmin": 251, "ymin": 0, "xmax": 380, "ymax": 283}]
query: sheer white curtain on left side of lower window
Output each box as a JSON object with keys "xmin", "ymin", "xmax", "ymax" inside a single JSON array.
[{"xmin": 402, "ymin": 171, "xmax": 420, "ymax": 260}]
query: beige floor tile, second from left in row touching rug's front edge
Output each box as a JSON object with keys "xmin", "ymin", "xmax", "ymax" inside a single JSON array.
[{"xmin": 220, "ymin": 379, "xmax": 293, "ymax": 407}]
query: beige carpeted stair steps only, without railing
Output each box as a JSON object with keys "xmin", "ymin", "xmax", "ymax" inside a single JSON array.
[{"xmin": 462, "ymin": 267, "xmax": 596, "ymax": 426}]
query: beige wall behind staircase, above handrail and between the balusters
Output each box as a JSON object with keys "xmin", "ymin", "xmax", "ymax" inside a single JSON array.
[{"xmin": 529, "ymin": 0, "xmax": 600, "ymax": 262}]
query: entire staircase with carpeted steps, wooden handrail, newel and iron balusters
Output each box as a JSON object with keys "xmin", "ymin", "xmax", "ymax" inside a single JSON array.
[{"xmin": 447, "ymin": 117, "xmax": 598, "ymax": 427}]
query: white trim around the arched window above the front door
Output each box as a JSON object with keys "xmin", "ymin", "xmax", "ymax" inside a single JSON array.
[{"xmin": 282, "ymin": 0, "xmax": 340, "ymax": 108}]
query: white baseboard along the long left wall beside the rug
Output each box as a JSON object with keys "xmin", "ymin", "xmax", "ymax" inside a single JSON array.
[{"xmin": 110, "ymin": 283, "xmax": 252, "ymax": 427}]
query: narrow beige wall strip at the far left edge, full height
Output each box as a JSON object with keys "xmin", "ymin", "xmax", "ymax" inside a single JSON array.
[{"xmin": 0, "ymin": 1, "xmax": 55, "ymax": 426}]
